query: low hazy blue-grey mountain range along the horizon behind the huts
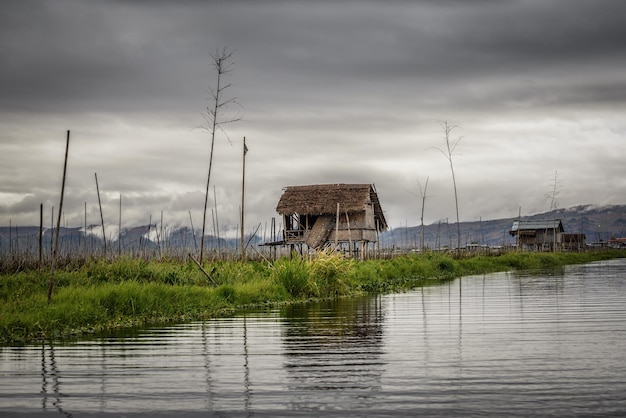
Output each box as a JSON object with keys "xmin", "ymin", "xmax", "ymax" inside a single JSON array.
[{"xmin": 0, "ymin": 205, "xmax": 626, "ymax": 254}]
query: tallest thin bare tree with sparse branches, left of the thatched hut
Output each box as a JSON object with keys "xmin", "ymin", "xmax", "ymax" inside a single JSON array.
[{"xmin": 199, "ymin": 48, "xmax": 242, "ymax": 263}]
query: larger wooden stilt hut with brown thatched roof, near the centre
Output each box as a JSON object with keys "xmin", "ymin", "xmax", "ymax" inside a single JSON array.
[{"xmin": 276, "ymin": 184, "xmax": 387, "ymax": 257}]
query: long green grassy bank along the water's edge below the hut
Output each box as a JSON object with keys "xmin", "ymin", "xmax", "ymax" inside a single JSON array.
[{"xmin": 0, "ymin": 251, "xmax": 626, "ymax": 345}]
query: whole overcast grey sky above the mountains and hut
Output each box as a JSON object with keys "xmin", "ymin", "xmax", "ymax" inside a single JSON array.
[{"xmin": 0, "ymin": 0, "xmax": 626, "ymax": 237}]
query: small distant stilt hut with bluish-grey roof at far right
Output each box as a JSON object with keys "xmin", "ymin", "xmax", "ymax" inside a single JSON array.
[{"xmin": 509, "ymin": 219, "xmax": 564, "ymax": 251}]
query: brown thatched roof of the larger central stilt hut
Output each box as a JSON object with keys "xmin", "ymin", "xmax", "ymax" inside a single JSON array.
[{"xmin": 276, "ymin": 184, "xmax": 387, "ymax": 229}]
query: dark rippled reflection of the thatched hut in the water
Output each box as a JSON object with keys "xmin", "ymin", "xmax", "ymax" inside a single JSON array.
[{"xmin": 281, "ymin": 297, "xmax": 385, "ymax": 410}]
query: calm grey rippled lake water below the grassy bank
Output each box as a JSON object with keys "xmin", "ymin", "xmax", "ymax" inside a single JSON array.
[{"xmin": 0, "ymin": 260, "xmax": 626, "ymax": 417}]
